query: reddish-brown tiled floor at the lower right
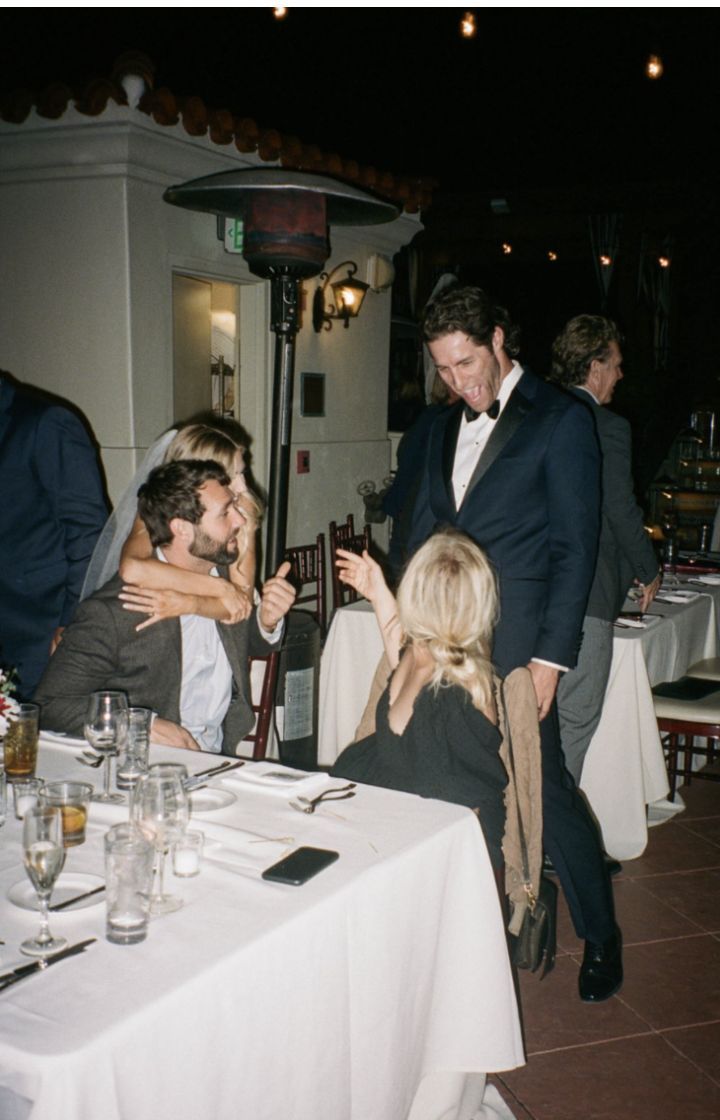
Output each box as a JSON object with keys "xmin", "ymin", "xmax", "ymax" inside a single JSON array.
[{"xmin": 493, "ymin": 764, "xmax": 720, "ymax": 1120}]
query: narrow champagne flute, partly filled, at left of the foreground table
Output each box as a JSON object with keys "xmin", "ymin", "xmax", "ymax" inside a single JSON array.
[{"xmin": 20, "ymin": 805, "xmax": 67, "ymax": 956}]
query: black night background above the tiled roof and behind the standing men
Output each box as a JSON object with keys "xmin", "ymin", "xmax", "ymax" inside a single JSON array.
[{"xmin": 0, "ymin": 8, "xmax": 720, "ymax": 488}]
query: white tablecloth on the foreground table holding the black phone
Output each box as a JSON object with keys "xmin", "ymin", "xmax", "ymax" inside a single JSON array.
[{"xmin": 0, "ymin": 735, "xmax": 524, "ymax": 1120}]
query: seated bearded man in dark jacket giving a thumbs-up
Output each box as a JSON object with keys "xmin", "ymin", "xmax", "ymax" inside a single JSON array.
[{"xmin": 35, "ymin": 459, "xmax": 294, "ymax": 754}]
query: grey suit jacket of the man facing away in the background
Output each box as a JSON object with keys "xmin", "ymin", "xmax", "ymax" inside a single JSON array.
[{"xmin": 573, "ymin": 386, "xmax": 657, "ymax": 619}]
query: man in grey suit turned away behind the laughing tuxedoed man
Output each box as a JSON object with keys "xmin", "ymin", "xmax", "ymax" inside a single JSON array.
[{"xmin": 551, "ymin": 315, "xmax": 660, "ymax": 783}]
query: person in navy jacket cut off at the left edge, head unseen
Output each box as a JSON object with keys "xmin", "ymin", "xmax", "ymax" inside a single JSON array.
[{"xmin": 0, "ymin": 371, "xmax": 107, "ymax": 698}]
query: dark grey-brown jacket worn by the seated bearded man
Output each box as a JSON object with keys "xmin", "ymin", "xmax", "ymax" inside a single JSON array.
[{"xmin": 35, "ymin": 576, "xmax": 277, "ymax": 754}]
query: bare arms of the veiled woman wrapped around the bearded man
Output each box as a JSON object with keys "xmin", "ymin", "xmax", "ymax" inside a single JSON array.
[{"xmin": 120, "ymin": 517, "xmax": 254, "ymax": 629}]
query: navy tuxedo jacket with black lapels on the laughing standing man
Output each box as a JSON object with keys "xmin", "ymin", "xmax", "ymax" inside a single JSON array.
[{"xmin": 410, "ymin": 372, "xmax": 600, "ymax": 675}]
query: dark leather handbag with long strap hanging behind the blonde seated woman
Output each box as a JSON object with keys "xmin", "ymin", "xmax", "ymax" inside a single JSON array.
[{"xmin": 501, "ymin": 688, "xmax": 558, "ymax": 980}]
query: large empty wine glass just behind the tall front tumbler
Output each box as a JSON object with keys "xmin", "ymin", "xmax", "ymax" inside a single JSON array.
[{"xmin": 131, "ymin": 765, "xmax": 190, "ymax": 914}]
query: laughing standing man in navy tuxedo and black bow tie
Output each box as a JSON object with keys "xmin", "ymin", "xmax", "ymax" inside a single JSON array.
[{"xmin": 410, "ymin": 288, "xmax": 623, "ymax": 1002}]
